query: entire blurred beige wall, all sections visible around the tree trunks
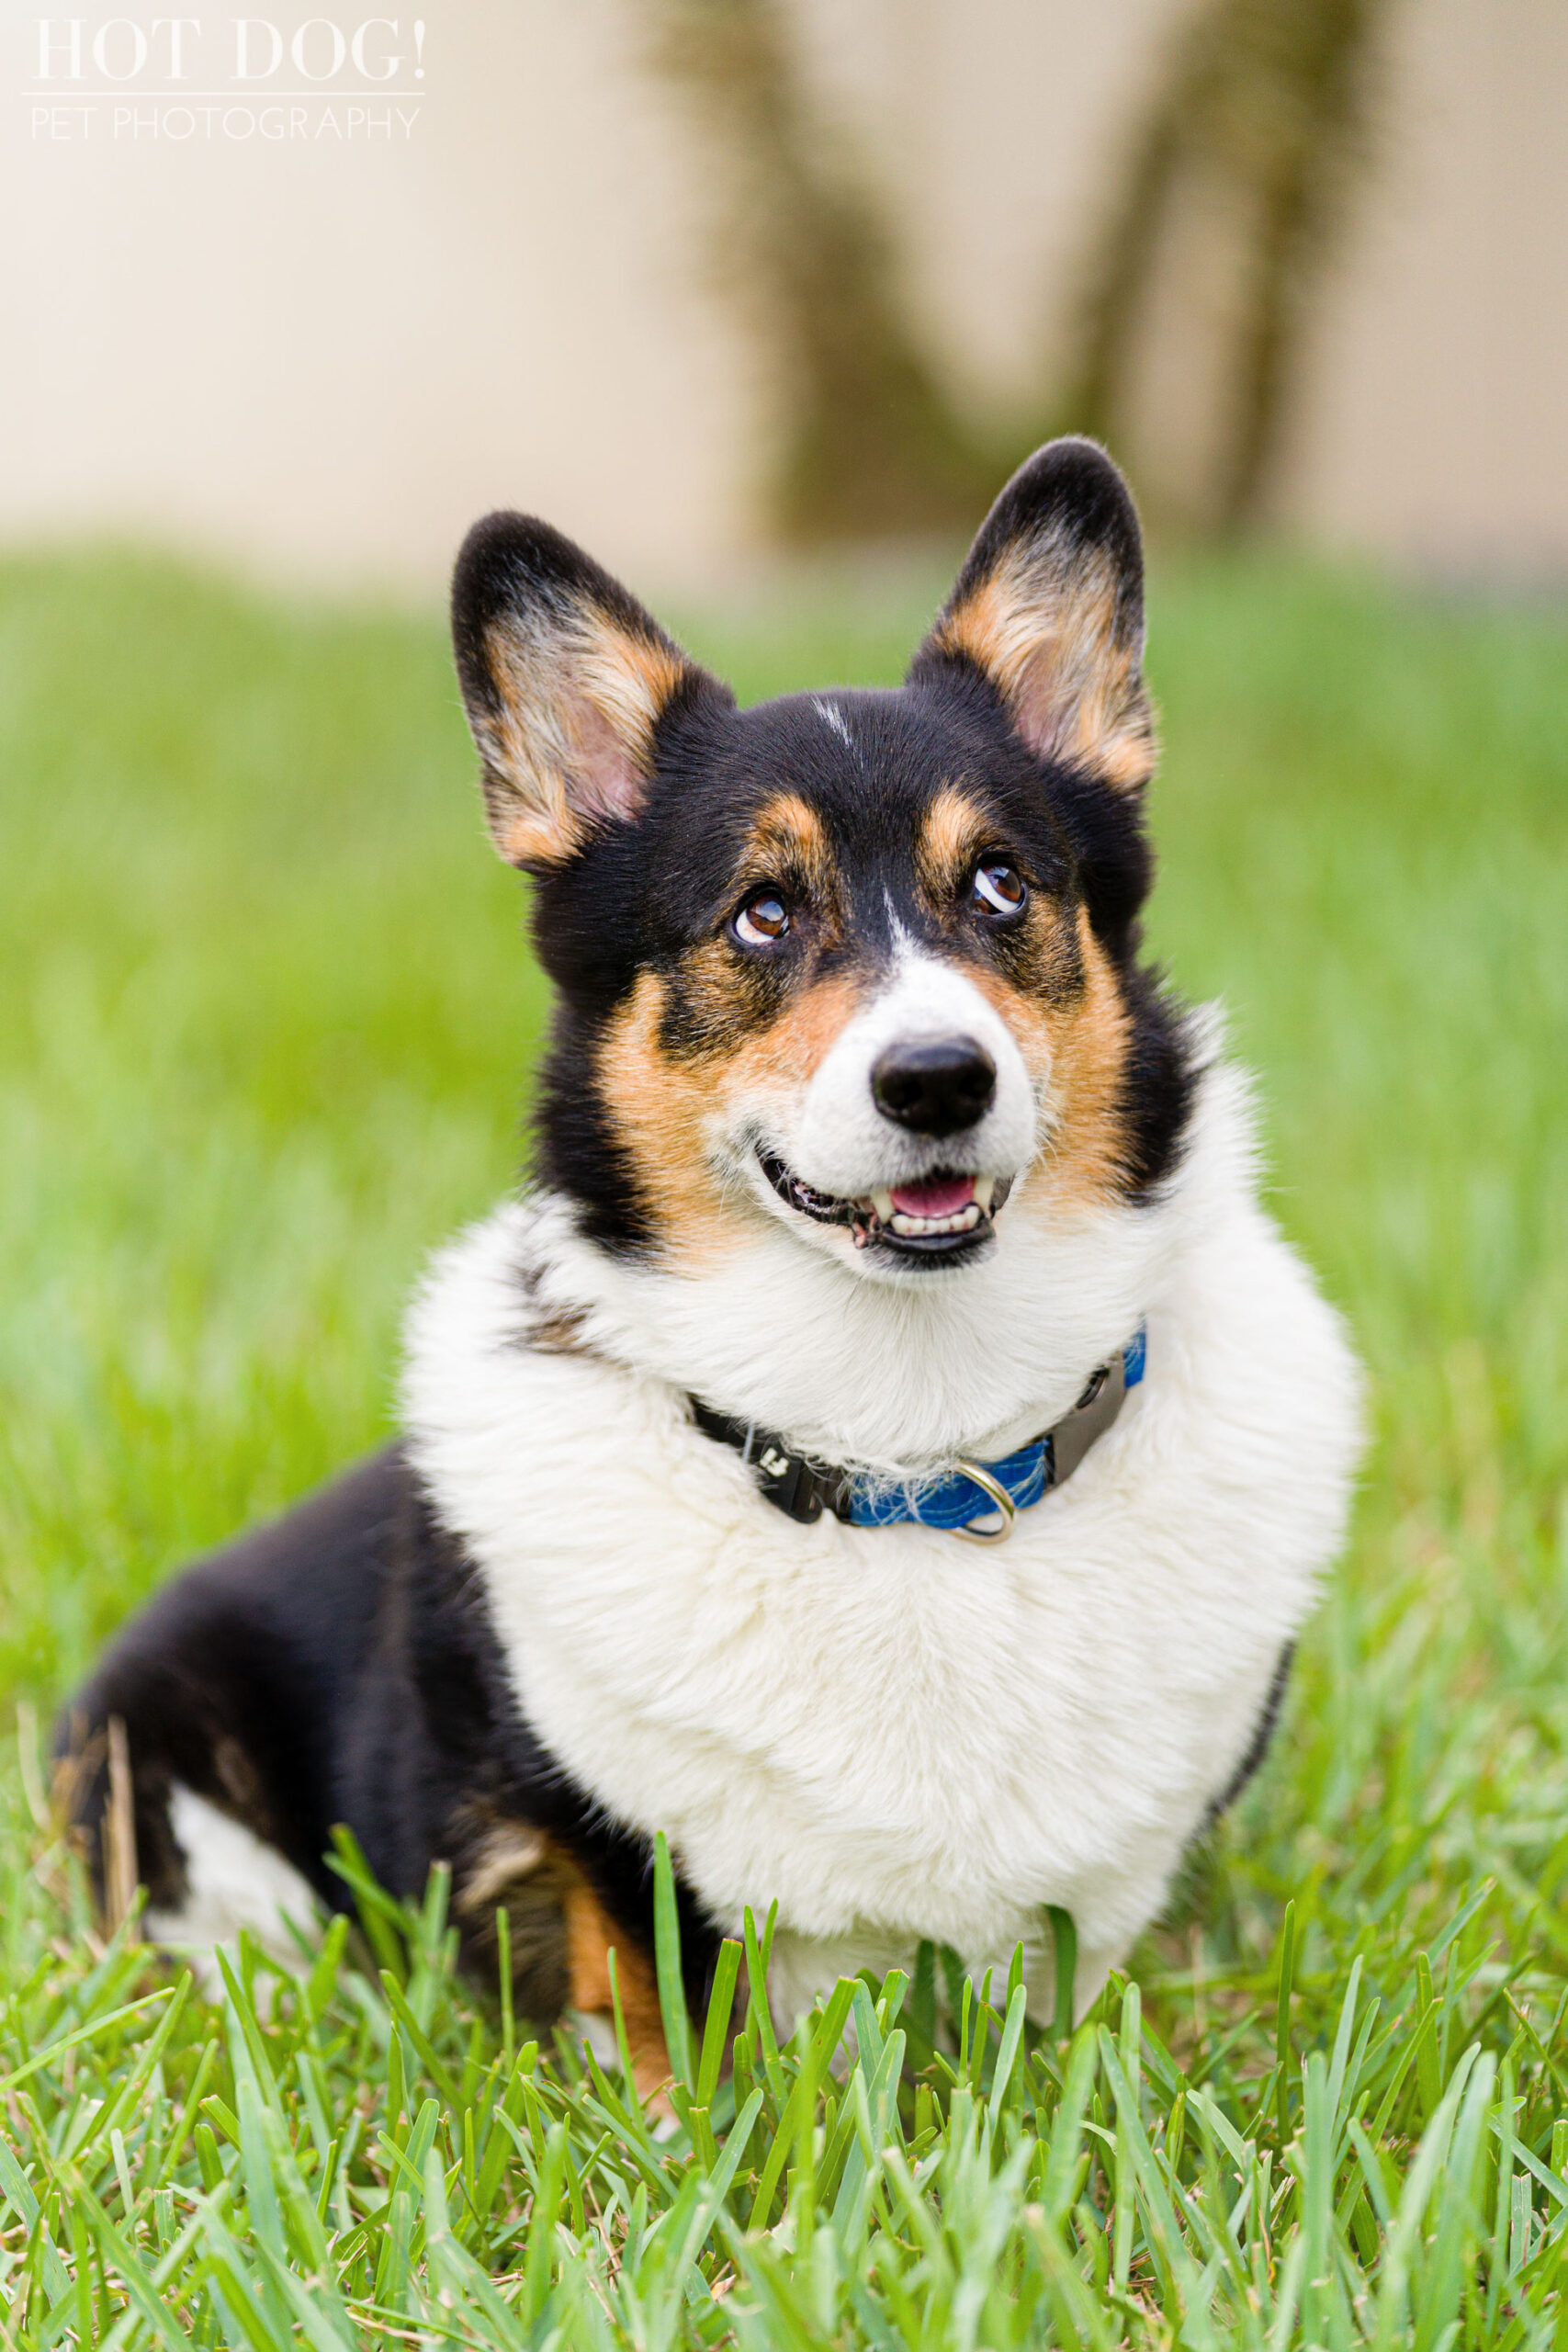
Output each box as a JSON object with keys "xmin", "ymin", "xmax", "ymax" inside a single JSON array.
[{"xmin": 0, "ymin": 0, "xmax": 1568, "ymax": 595}]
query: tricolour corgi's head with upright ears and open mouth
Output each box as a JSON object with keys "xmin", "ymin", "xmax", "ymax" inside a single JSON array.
[{"xmin": 454, "ymin": 440, "xmax": 1187, "ymax": 1282}]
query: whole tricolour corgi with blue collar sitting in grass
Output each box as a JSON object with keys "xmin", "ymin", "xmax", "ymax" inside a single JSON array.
[{"xmin": 62, "ymin": 440, "xmax": 1361, "ymax": 2084}]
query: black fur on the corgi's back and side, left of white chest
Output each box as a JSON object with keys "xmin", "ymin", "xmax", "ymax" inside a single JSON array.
[{"xmin": 56, "ymin": 1446, "xmax": 717, "ymax": 2023}]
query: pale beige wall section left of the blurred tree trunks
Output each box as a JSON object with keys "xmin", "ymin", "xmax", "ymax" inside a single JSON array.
[{"xmin": 0, "ymin": 0, "xmax": 745, "ymax": 591}]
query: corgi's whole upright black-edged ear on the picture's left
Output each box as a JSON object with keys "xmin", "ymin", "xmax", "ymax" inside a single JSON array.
[{"xmin": 451, "ymin": 515, "xmax": 728, "ymax": 870}]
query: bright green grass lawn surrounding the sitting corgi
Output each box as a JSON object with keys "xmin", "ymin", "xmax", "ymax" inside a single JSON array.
[{"xmin": 0, "ymin": 538, "xmax": 1568, "ymax": 2352}]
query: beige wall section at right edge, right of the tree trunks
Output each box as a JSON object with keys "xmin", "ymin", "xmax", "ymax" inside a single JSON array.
[{"xmin": 1283, "ymin": 0, "xmax": 1568, "ymax": 579}]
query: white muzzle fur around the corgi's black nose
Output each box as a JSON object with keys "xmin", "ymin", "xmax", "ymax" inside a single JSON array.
[{"xmin": 778, "ymin": 948, "xmax": 1039, "ymax": 1197}]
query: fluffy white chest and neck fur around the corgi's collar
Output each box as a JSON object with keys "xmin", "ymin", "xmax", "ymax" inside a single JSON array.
[{"xmin": 407, "ymin": 1072, "xmax": 1359, "ymax": 2008}]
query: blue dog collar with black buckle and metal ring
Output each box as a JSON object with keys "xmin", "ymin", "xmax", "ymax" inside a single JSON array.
[{"xmin": 691, "ymin": 1329, "xmax": 1147, "ymax": 1543}]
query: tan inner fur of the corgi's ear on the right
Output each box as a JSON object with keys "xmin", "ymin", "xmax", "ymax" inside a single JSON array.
[{"xmin": 936, "ymin": 541, "xmax": 1155, "ymax": 790}]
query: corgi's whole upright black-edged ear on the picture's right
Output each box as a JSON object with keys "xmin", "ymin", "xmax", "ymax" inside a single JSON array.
[{"xmin": 909, "ymin": 440, "xmax": 1155, "ymax": 793}]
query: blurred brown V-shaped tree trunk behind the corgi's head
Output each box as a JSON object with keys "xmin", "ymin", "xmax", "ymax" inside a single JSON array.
[{"xmin": 639, "ymin": 0, "xmax": 1389, "ymax": 541}]
